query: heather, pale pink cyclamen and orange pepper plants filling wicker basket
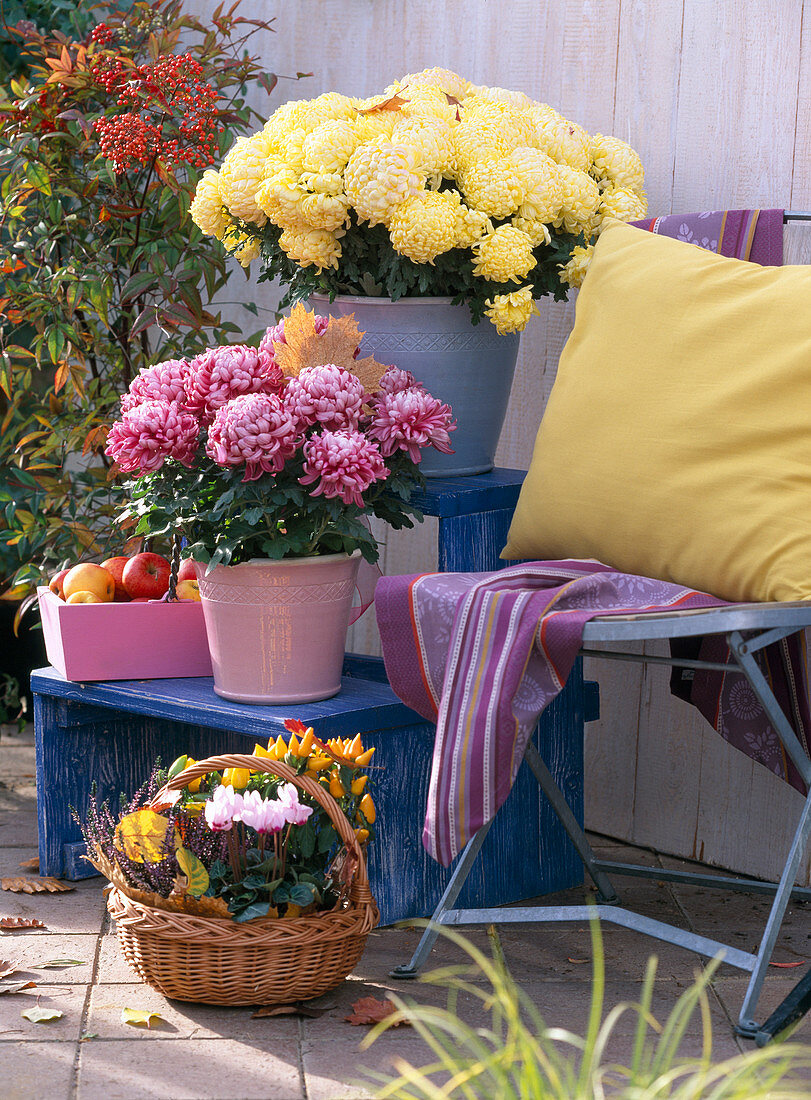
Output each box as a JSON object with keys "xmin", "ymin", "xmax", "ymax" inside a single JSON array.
[{"xmin": 75, "ymin": 719, "xmax": 376, "ymax": 921}]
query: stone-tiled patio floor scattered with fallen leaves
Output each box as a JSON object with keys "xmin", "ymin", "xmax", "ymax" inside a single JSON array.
[{"xmin": 0, "ymin": 728, "xmax": 811, "ymax": 1100}]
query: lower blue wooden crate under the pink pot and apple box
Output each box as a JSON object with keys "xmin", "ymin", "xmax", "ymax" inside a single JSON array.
[{"xmin": 32, "ymin": 660, "xmax": 583, "ymax": 924}]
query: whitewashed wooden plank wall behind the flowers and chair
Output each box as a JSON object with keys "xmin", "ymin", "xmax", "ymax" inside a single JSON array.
[{"xmin": 188, "ymin": 0, "xmax": 811, "ymax": 876}]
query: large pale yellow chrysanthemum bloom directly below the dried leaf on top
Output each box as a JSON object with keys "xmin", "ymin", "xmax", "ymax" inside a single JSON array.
[{"xmin": 343, "ymin": 141, "xmax": 425, "ymax": 226}]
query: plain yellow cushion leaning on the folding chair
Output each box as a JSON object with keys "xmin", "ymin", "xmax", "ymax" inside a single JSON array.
[{"xmin": 502, "ymin": 216, "xmax": 811, "ymax": 602}]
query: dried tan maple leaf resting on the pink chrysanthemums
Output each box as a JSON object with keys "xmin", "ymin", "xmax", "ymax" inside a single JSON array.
[{"xmin": 273, "ymin": 303, "xmax": 386, "ymax": 393}]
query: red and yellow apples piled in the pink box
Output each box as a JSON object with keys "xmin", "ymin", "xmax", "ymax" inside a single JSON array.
[{"xmin": 48, "ymin": 551, "xmax": 200, "ymax": 604}]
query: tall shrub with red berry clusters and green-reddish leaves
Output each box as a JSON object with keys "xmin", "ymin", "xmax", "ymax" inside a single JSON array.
[{"xmin": 0, "ymin": 0, "xmax": 303, "ymax": 586}]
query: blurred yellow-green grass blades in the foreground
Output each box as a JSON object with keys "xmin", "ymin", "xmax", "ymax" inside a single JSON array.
[{"xmin": 365, "ymin": 920, "xmax": 811, "ymax": 1100}]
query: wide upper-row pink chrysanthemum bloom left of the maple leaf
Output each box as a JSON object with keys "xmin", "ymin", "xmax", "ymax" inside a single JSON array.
[{"xmin": 186, "ymin": 344, "xmax": 283, "ymax": 424}]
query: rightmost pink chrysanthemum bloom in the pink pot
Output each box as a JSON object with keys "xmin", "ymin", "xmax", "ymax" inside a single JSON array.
[{"xmin": 366, "ymin": 386, "xmax": 456, "ymax": 462}]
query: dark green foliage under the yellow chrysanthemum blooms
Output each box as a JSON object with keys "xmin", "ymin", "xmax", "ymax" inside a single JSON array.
[{"xmin": 256, "ymin": 211, "xmax": 585, "ymax": 323}]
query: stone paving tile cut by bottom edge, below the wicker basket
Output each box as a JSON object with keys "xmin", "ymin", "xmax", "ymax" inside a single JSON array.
[{"xmin": 76, "ymin": 1038, "xmax": 303, "ymax": 1100}]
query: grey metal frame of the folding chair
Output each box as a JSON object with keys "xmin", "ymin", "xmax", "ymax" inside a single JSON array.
[{"xmin": 392, "ymin": 212, "xmax": 811, "ymax": 1045}]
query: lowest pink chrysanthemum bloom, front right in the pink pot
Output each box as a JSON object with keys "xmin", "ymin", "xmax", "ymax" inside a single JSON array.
[{"xmin": 298, "ymin": 430, "xmax": 388, "ymax": 508}]
